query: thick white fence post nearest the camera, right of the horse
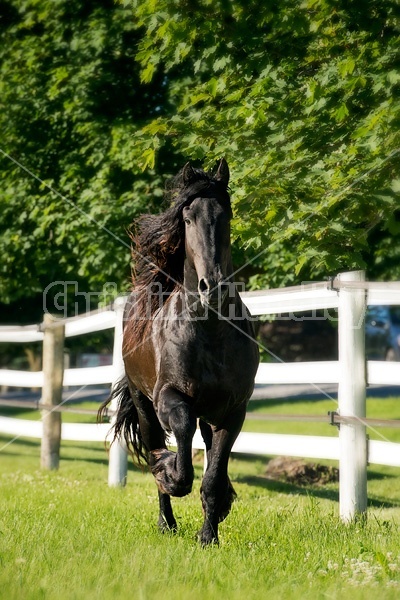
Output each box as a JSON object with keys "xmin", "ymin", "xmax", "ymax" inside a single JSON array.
[{"xmin": 338, "ymin": 271, "xmax": 367, "ymax": 522}]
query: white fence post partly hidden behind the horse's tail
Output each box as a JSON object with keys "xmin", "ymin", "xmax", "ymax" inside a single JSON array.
[{"xmin": 108, "ymin": 297, "xmax": 128, "ymax": 487}]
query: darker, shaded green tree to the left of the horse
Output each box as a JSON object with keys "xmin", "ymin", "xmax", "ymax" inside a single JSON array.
[{"xmin": 0, "ymin": 0, "xmax": 177, "ymax": 321}]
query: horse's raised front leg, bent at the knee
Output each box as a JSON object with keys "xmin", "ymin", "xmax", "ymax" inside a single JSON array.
[{"xmin": 151, "ymin": 388, "xmax": 196, "ymax": 496}]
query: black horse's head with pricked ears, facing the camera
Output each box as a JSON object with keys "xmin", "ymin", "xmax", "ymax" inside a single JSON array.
[{"xmin": 182, "ymin": 159, "xmax": 232, "ymax": 308}]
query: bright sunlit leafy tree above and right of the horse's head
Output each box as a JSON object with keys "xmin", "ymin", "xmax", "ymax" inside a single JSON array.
[{"xmin": 125, "ymin": 0, "xmax": 400, "ymax": 286}]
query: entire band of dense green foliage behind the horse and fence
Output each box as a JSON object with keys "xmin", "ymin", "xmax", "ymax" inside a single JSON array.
[{"xmin": 0, "ymin": 0, "xmax": 400, "ymax": 318}]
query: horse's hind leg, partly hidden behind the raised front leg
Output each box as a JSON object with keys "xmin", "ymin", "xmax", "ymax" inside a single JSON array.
[{"xmin": 131, "ymin": 391, "xmax": 177, "ymax": 532}]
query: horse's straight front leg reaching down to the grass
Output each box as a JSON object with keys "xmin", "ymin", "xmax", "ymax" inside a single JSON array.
[{"xmin": 199, "ymin": 407, "xmax": 246, "ymax": 546}]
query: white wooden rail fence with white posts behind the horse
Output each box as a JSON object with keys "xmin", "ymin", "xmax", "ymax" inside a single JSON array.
[{"xmin": 0, "ymin": 271, "xmax": 400, "ymax": 521}]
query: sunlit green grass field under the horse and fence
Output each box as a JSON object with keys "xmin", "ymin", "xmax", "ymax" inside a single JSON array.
[{"xmin": 0, "ymin": 398, "xmax": 400, "ymax": 600}]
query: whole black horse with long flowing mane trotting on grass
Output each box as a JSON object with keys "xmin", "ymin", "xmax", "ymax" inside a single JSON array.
[{"xmin": 99, "ymin": 159, "xmax": 259, "ymax": 545}]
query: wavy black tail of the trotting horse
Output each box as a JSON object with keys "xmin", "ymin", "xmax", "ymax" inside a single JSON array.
[{"xmin": 97, "ymin": 376, "xmax": 148, "ymax": 465}]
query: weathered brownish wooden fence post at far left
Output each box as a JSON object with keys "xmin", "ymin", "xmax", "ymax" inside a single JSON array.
[{"xmin": 40, "ymin": 314, "xmax": 65, "ymax": 469}]
